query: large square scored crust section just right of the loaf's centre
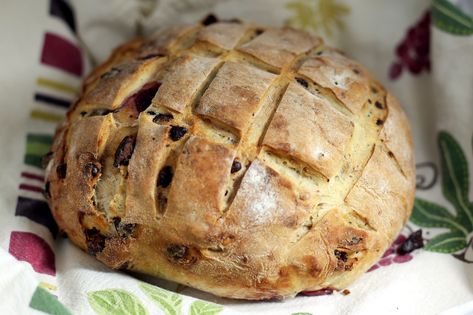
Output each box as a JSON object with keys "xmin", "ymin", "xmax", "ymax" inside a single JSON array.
[{"xmin": 263, "ymin": 83, "xmax": 353, "ymax": 178}]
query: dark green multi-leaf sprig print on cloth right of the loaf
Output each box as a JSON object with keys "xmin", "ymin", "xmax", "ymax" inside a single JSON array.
[{"xmin": 411, "ymin": 131, "xmax": 473, "ymax": 261}]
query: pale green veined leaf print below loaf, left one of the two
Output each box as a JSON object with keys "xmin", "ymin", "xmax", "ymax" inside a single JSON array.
[{"xmin": 88, "ymin": 289, "xmax": 148, "ymax": 315}]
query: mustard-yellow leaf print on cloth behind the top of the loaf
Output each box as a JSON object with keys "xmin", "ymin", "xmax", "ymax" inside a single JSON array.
[{"xmin": 285, "ymin": 0, "xmax": 350, "ymax": 37}]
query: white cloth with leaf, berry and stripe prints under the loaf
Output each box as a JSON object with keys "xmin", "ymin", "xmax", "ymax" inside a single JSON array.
[{"xmin": 0, "ymin": 0, "xmax": 473, "ymax": 315}]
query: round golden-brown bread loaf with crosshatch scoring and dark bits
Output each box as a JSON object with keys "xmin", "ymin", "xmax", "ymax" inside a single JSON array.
[{"xmin": 46, "ymin": 21, "xmax": 415, "ymax": 300}]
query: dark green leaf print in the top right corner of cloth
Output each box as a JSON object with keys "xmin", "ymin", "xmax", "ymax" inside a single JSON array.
[{"xmin": 432, "ymin": 0, "xmax": 473, "ymax": 36}]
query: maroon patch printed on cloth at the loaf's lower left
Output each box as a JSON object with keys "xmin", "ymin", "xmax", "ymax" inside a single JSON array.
[{"xmin": 8, "ymin": 231, "xmax": 56, "ymax": 276}]
